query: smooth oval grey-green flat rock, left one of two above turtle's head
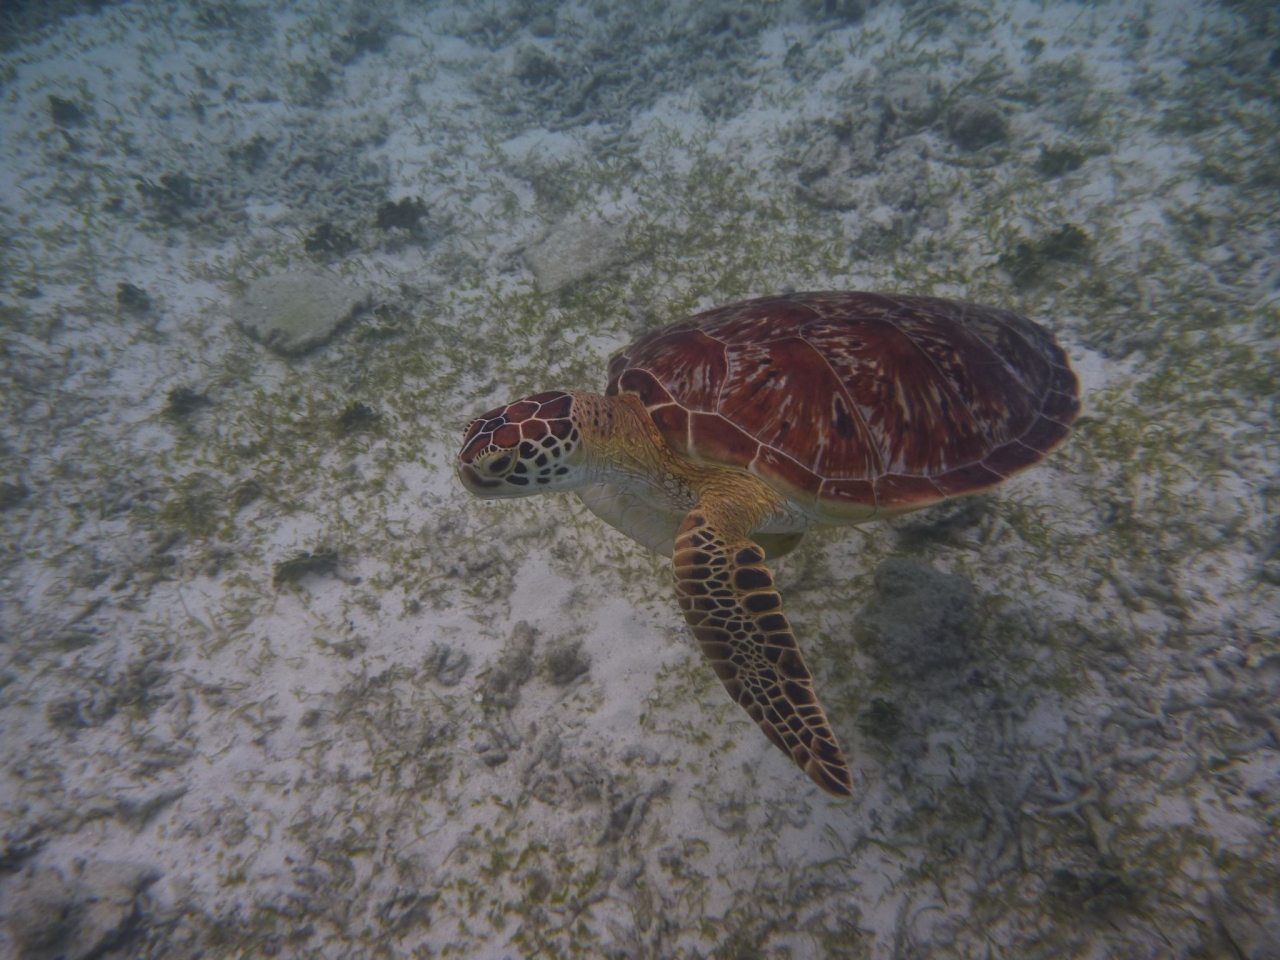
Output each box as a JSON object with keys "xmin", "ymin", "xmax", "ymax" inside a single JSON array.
[{"xmin": 232, "ymin": 270, "xmax": 369, "ymax": 356}]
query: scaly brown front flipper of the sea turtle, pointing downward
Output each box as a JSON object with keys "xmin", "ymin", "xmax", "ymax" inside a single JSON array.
[{"xmin": 672, "ymin": 498, "xmax": 852, "ymax": 796}]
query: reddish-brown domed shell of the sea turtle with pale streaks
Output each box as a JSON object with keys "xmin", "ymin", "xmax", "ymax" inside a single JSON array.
[{"xmin": 607, "ymin": 293, "xmax": 1080, "ymax": 520}]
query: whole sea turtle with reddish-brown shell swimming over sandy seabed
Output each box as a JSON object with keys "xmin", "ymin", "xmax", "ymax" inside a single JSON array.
[{"xmin": 457, "ymin": 292, "xmax": 1079, "ymax": 796}]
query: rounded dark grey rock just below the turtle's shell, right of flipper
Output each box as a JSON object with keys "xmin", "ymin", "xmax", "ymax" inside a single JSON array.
[{"xmin": 855, "ymin": 558, "xmax": 978, "ymax": 677}]
